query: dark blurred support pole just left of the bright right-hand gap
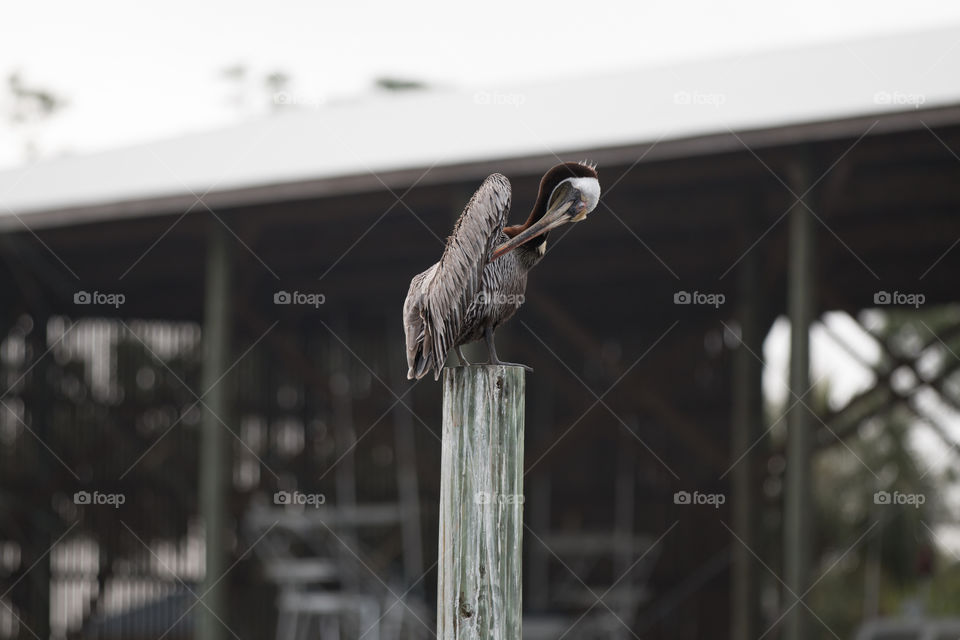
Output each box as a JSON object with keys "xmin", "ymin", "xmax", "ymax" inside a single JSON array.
[{"xmin": 730, "ymin": 241, "xmax": 763, "ymax": 640}]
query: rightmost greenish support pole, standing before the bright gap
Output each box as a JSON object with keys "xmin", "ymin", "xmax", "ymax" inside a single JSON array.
[{"xmin": 783, "ymin": 163, "xmax": 814, "ymax": 640}]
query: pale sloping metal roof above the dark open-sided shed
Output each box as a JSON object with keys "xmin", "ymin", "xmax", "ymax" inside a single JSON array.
[{"xmin": 0, "ymin": 28, "xmax": 960, "ymax": 223}]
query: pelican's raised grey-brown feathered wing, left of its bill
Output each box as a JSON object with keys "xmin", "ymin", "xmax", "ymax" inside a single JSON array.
[{"xmin": 422, "ymin": 173, "xmax": 511, "ymax": 377}]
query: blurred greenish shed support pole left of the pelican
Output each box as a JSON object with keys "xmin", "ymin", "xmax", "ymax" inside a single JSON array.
[{"xmin": 196, "ymin": 224, "xmax": 232, "ymax": 640}]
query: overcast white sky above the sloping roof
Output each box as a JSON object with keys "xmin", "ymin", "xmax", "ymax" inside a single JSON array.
[{"xmin": 0, "ymin": 0, "xmax": 960, "ymax": 166}]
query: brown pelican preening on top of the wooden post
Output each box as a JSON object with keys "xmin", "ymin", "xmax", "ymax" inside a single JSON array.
[{"xmin": 403, "ymin": 162, "xmax": 600, "ymax": 379}]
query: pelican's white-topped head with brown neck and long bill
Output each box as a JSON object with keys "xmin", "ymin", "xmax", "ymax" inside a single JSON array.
[{"xmin": 491, "ymin": 161, "xmax": 600, "ymax": 260}]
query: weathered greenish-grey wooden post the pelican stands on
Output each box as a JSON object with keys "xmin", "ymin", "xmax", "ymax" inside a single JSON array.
[{"xmin": 437, "ymin": 365, "xmax": 524, "ymax": 640}]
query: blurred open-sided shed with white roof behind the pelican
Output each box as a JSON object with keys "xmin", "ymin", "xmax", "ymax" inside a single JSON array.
[{"xmin": 0, "ymin": 2, "xmax": 960, "ymax": 640}]
